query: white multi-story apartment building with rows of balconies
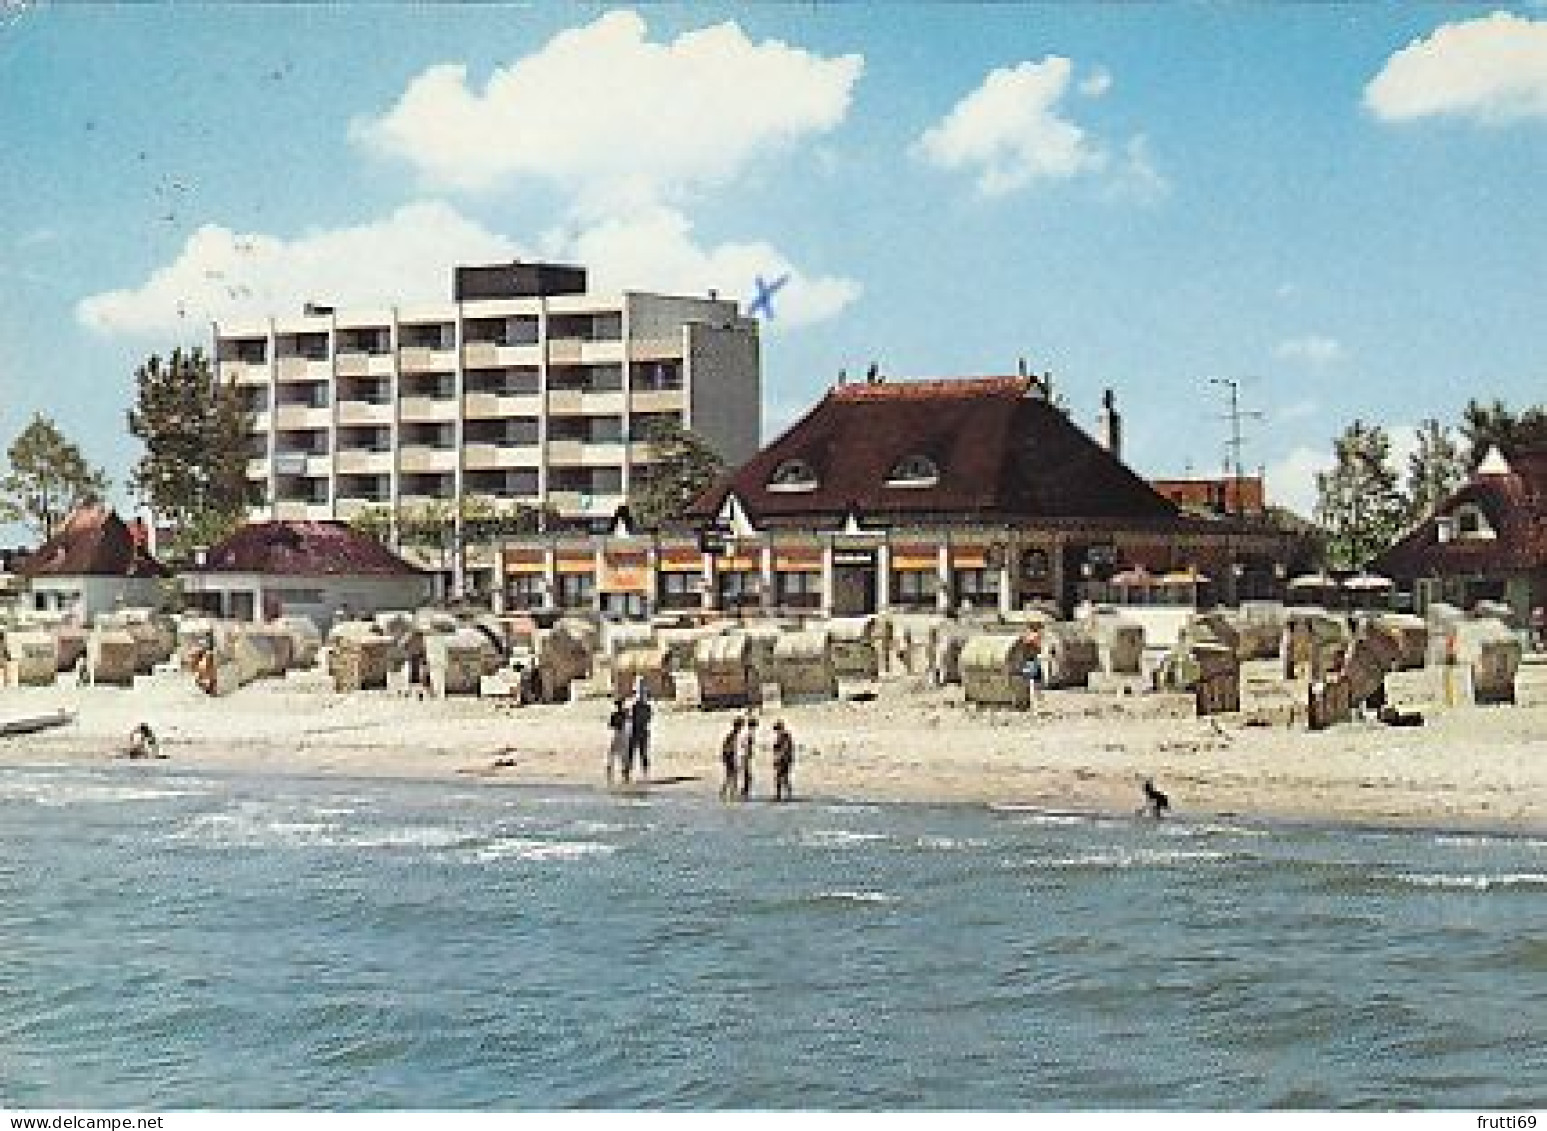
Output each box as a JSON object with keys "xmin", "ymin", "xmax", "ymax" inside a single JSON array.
[{"xmin": 215, "ymin": 263, "xmax": 761, "ymax": 535}]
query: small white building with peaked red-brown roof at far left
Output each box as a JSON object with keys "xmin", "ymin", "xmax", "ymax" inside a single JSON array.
[{"xmin": 17, "ymin": 503, "xmax": 170, "ymax": 624}]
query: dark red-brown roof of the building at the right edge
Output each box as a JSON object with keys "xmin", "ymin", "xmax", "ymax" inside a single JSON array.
[{"xmin": 1371, "ymin": 447, "xmax": 1547, "ymax": 580}]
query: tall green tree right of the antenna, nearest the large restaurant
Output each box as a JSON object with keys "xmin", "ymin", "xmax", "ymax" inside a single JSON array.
[{"xmin": 1315, "ymin": 421, "xmax": 1408, "ymax": 569}]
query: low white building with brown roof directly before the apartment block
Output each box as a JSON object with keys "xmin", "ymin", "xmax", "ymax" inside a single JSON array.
[{"xmin": 179, "ymin": 521, "xmax": 432, "ymax": 631}]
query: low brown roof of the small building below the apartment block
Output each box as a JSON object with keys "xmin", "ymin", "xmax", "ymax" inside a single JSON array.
[{"xmin": 189, "ymin": 521, "xmax": 422, "ymax": 577}]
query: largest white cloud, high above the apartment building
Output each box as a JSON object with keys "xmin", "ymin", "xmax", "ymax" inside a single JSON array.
[{"xmin": 351, "ymin": 11, "xmax": 865, "ymax": 204}]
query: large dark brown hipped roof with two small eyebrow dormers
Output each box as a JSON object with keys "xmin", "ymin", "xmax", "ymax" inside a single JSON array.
[{"xmin": 688, "ymin": 378, "xmax": 1176, "ymax": 524}]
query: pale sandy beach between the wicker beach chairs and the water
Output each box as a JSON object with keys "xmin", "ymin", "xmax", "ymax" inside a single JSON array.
[{"xmin": 0, "ymin": 664, "xmax": 1547, "ymax": 832}]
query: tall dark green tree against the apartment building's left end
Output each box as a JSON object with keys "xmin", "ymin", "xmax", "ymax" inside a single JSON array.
[{"xmin": 128, "ymin": 347, "xmax": 251, "ymax": 557}]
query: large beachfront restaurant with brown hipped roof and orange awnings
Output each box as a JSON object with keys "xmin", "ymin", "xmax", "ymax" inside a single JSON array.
[{"xmin": 488, "ymin": 378, "xmax": 1309, "ymax": 616}]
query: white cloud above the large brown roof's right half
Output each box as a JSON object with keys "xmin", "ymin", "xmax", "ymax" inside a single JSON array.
[{"xmin": 913, "ymin": 56, "xmax": 1108, "ymax": 196}]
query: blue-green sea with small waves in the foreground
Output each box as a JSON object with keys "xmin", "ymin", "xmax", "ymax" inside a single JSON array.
[{"xmin": 0, "ymin": 753, "xmax": 1547, "ymax": 1112}]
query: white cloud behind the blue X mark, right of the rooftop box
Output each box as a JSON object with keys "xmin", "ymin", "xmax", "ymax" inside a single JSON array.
[{"xmin": 545, "ymin": 206, "xmax": 860, "ymax": 330}]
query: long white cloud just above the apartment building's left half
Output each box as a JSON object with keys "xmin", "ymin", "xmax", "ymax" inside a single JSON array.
[{"xmin": 76, "ymin": 201, "xmax": 521, "ymax": 336}]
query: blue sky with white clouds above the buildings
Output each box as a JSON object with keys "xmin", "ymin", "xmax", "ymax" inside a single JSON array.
[{"xmin": 0, "ymin": 0, "xmax": 1547, "ymax": 532}]
